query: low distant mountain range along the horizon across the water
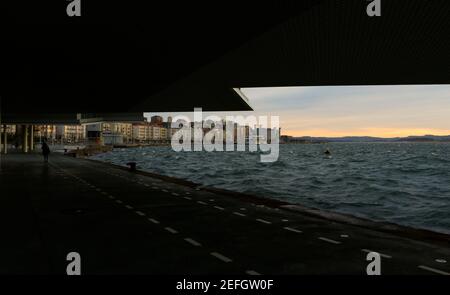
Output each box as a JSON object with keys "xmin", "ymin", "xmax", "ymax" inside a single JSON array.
[{"xmin": 286, "ymin": 135, "xmax": 450, "ymax": 142}]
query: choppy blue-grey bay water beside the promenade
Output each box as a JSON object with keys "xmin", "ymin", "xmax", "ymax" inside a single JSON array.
[{"xmin": 94, "ymin": 143, "xmax": 450, "ymax": 233}]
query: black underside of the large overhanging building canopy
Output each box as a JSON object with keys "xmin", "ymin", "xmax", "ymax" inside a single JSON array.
[{"xmin": 0, "ymin": 0, "xmax": 450, "ymax": 118}]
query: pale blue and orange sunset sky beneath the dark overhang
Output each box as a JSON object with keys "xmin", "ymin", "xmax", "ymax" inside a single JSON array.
[{"xmin": 145, "ymin": 85, "xmax": 450, "ymax": 138}]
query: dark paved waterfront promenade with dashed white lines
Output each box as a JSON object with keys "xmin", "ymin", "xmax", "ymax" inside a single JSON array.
[{"xmin": 0, "ymin": 154, "xmax": 450, "ymax": 275}]
